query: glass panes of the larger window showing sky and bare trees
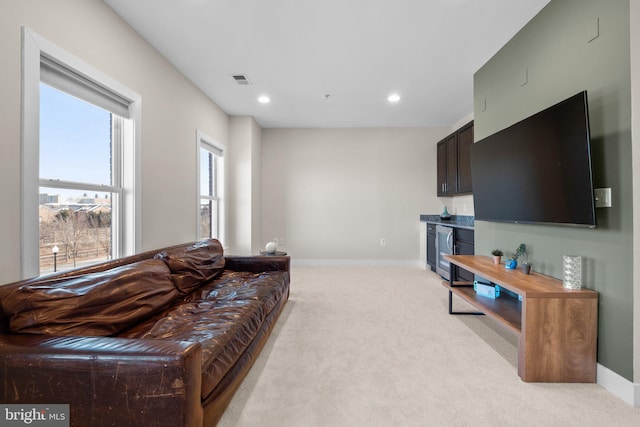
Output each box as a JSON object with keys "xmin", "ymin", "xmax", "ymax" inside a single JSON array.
[{"xmin": 38, "ymin": 84, "xmax": 121, "ymax": 274}]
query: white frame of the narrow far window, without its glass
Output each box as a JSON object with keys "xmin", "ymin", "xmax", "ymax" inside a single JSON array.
[{"xmin": 196, "ymin": 130, "xmax": 226, "ymax": 245}]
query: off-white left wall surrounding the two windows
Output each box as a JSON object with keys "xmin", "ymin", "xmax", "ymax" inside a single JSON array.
[{"xmin": 0, "ymin": 0, "xmax": 228, "ymax": 283}]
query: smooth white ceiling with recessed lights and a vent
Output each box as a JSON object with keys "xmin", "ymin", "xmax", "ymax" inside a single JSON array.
[{"xmin": 104, "ymin": 0, "xmax": 549, "ymax": 128}]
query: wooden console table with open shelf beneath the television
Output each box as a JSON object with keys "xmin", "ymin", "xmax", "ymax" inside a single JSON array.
[{"xmin": 443, "ymin": 255, "xmax": 598, "ymax": 383}]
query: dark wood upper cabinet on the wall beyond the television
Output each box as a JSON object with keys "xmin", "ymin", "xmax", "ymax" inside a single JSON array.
[{"xmin": 437, "ymin": 121, "xmax": 473, "ymax": 197}]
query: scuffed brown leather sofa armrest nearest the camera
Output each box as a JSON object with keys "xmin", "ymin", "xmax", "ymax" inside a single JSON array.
[{"xmin": 0, "ymin": 334, "xmax": 202, "ymax": 426}]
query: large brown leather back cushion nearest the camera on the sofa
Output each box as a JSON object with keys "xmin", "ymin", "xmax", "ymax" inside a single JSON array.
[{"xmin": 2, "ymin": 259, "xmax": 180, "ymax": 336}]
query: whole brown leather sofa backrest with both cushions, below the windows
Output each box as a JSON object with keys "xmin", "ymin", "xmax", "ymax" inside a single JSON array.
[{"xmin": 0, "ymin": 239, "xmax": 224, "ymax": 335}]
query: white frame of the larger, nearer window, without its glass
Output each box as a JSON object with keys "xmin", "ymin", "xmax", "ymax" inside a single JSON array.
[{"xmin": 21, "ymin": 27, "xmax": 142, "ymax": 278}]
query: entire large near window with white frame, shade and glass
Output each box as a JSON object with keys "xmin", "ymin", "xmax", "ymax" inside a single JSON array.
[{"xmin": 22, "ymin": 29, "xmax": 140, "ymax": 278}]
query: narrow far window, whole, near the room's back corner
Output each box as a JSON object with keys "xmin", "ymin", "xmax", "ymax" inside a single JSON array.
[{"xmin": 197, "ymin": 132, "xmax": 224, "ymax": 241}]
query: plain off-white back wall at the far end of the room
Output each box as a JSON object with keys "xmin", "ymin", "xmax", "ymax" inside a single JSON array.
[{"xmin": 262, "ymin": 128, "xmax": 451, "ymax": 265}]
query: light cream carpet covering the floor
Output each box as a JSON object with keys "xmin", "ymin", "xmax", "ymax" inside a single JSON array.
[{"xmin": 219, "ymin": 267, "xmax": 640, "ymax": 427}]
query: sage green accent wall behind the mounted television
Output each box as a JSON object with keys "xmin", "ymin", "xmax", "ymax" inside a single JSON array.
[{"xmin": 474, "ymin": 0, "xmax": 633, "ymax": 381}]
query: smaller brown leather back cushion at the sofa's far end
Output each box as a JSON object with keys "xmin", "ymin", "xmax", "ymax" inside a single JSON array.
[{"xmin": 156, "ymin": 239, "xmax": 224, "ymax": 294}]
